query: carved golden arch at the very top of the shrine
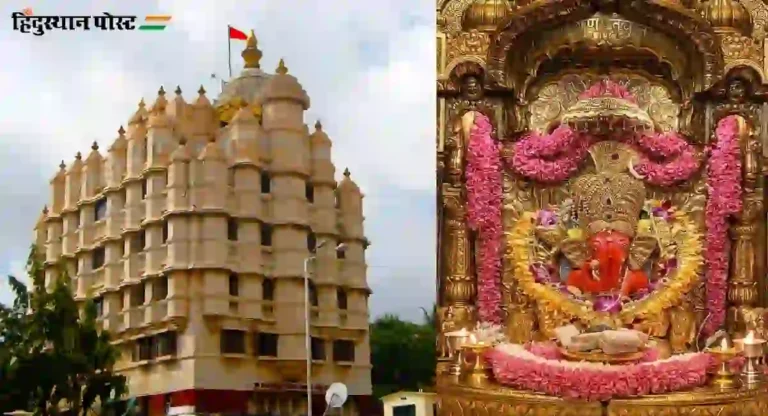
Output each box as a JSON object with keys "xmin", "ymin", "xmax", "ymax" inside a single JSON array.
[{"xmin": 487, "ymin": 0, "xmax": 724, "ymax": 97}]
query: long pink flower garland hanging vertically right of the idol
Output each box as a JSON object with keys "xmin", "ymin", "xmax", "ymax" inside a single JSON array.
[{"xmin": 704, "ymin": 116, "xmax": 742, "ymax": 334}]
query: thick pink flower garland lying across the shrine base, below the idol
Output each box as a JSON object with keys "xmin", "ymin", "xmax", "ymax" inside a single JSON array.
[{"xmin": 486, "ymin": 345, "xmax": 712, "ymax": 401}]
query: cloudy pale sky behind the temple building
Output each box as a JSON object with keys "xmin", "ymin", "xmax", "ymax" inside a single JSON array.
[{"xmin": 0, "ymin": 0, "xmax": 436, "ymax": 320}]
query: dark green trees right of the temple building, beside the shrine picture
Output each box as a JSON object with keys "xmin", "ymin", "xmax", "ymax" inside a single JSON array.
[{"xmin": 370, "ymin": 308, "xmax": 437, "ymax": 397}]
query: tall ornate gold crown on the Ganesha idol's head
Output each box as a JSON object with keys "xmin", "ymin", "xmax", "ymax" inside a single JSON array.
[{"xmin": 572, "ymin": 172, "xmax": 645, "ymax": 236}]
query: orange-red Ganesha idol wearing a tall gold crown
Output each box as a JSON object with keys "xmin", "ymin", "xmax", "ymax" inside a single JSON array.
[{"xmin": 537, "ymin": 167, "xmax": 657, "ymax": 297}]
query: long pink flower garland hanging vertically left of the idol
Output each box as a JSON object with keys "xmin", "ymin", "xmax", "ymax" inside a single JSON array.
[{"xmin": 466, "ymin": 113, "xmax": 502, "ymax": 323}]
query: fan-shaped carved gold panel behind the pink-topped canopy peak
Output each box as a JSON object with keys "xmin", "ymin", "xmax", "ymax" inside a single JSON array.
[{"xmin": 529, "ymin": 71, "xmax": 681, "ymax": 132}]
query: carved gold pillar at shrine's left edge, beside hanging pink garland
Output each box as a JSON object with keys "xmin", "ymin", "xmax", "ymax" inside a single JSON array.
[{"xmin": 440, "ymin": 184, "xmax": 477, "ymax": 330}]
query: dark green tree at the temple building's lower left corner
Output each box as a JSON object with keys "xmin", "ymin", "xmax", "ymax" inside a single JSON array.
[{"xmin": 0, "ymin": 246, "xmax": 126, "ymax": 416}]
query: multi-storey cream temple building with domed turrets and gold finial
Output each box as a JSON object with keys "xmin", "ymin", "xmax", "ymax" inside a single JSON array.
[{"xmin": 35, "ymin": 32, "xmax": 371, "ymax": 415}]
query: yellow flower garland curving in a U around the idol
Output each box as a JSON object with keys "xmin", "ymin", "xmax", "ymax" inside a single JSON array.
[{"xmin": 505, "ymin": 211, "xmax": 704, "ymax": 324}]
